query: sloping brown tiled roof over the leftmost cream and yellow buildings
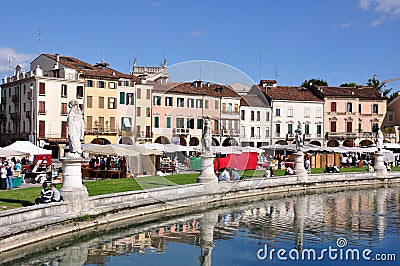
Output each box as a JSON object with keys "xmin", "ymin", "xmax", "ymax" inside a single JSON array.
[{"xmin": 43, "ymin": 54, "xmax": 141, "ymax": 83}]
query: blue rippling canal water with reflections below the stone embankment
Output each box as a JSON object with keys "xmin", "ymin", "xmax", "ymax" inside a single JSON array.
[{"xmin": 0, "ymin": 186, "xmax": 400, "ymax": 266}]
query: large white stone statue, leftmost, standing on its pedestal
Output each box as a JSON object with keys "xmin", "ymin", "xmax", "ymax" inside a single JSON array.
[{"xmin": 67, "ymin": 99, "xmax": 85, "ymax": 156}]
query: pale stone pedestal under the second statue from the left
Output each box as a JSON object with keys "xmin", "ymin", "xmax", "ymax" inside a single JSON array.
[{"xmin": 197, "ymin": 153, "xmax": 218, "ymax": 193}]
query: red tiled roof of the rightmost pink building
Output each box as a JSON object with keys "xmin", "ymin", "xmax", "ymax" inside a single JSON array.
[{"xmin": 312, "ymin": 86, "xmax": 385, "ymax": 100}]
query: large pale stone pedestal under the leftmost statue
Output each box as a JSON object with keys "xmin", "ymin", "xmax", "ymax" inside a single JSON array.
[{"xmin": 60, "ymin": 156, "xmax": 89, "ymax": 213}]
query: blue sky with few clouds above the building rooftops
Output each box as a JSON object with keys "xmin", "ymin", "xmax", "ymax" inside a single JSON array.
[{"xmin": 0, "ymin": 0, "xmax": 400, "ymax": 91}]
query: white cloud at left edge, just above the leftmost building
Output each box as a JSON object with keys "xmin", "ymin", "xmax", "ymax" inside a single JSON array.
[{"xmin": 0, "ymin": 47, "xmax": 36, "ymax": 72}]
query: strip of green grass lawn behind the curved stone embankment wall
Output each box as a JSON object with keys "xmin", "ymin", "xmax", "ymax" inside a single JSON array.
[{"xmin": 0, "ymin": 166, "xmax": 400, "ymax": 210}]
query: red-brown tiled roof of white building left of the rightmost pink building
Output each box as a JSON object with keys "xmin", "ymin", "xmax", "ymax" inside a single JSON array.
[{"xmin": 258, "ymin": 86, "xmax": 323, "ymax": 102}]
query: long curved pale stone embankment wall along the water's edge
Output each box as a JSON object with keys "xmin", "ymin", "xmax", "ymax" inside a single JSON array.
[{"xmin": 0, "ymin": 172, "xmax": 400, "ymax": 252}]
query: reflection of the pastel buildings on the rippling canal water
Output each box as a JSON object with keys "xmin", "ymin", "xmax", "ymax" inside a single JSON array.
[{"xmin": 0, "ymin": 185, "xmax": 400, "ymax": 266}]
